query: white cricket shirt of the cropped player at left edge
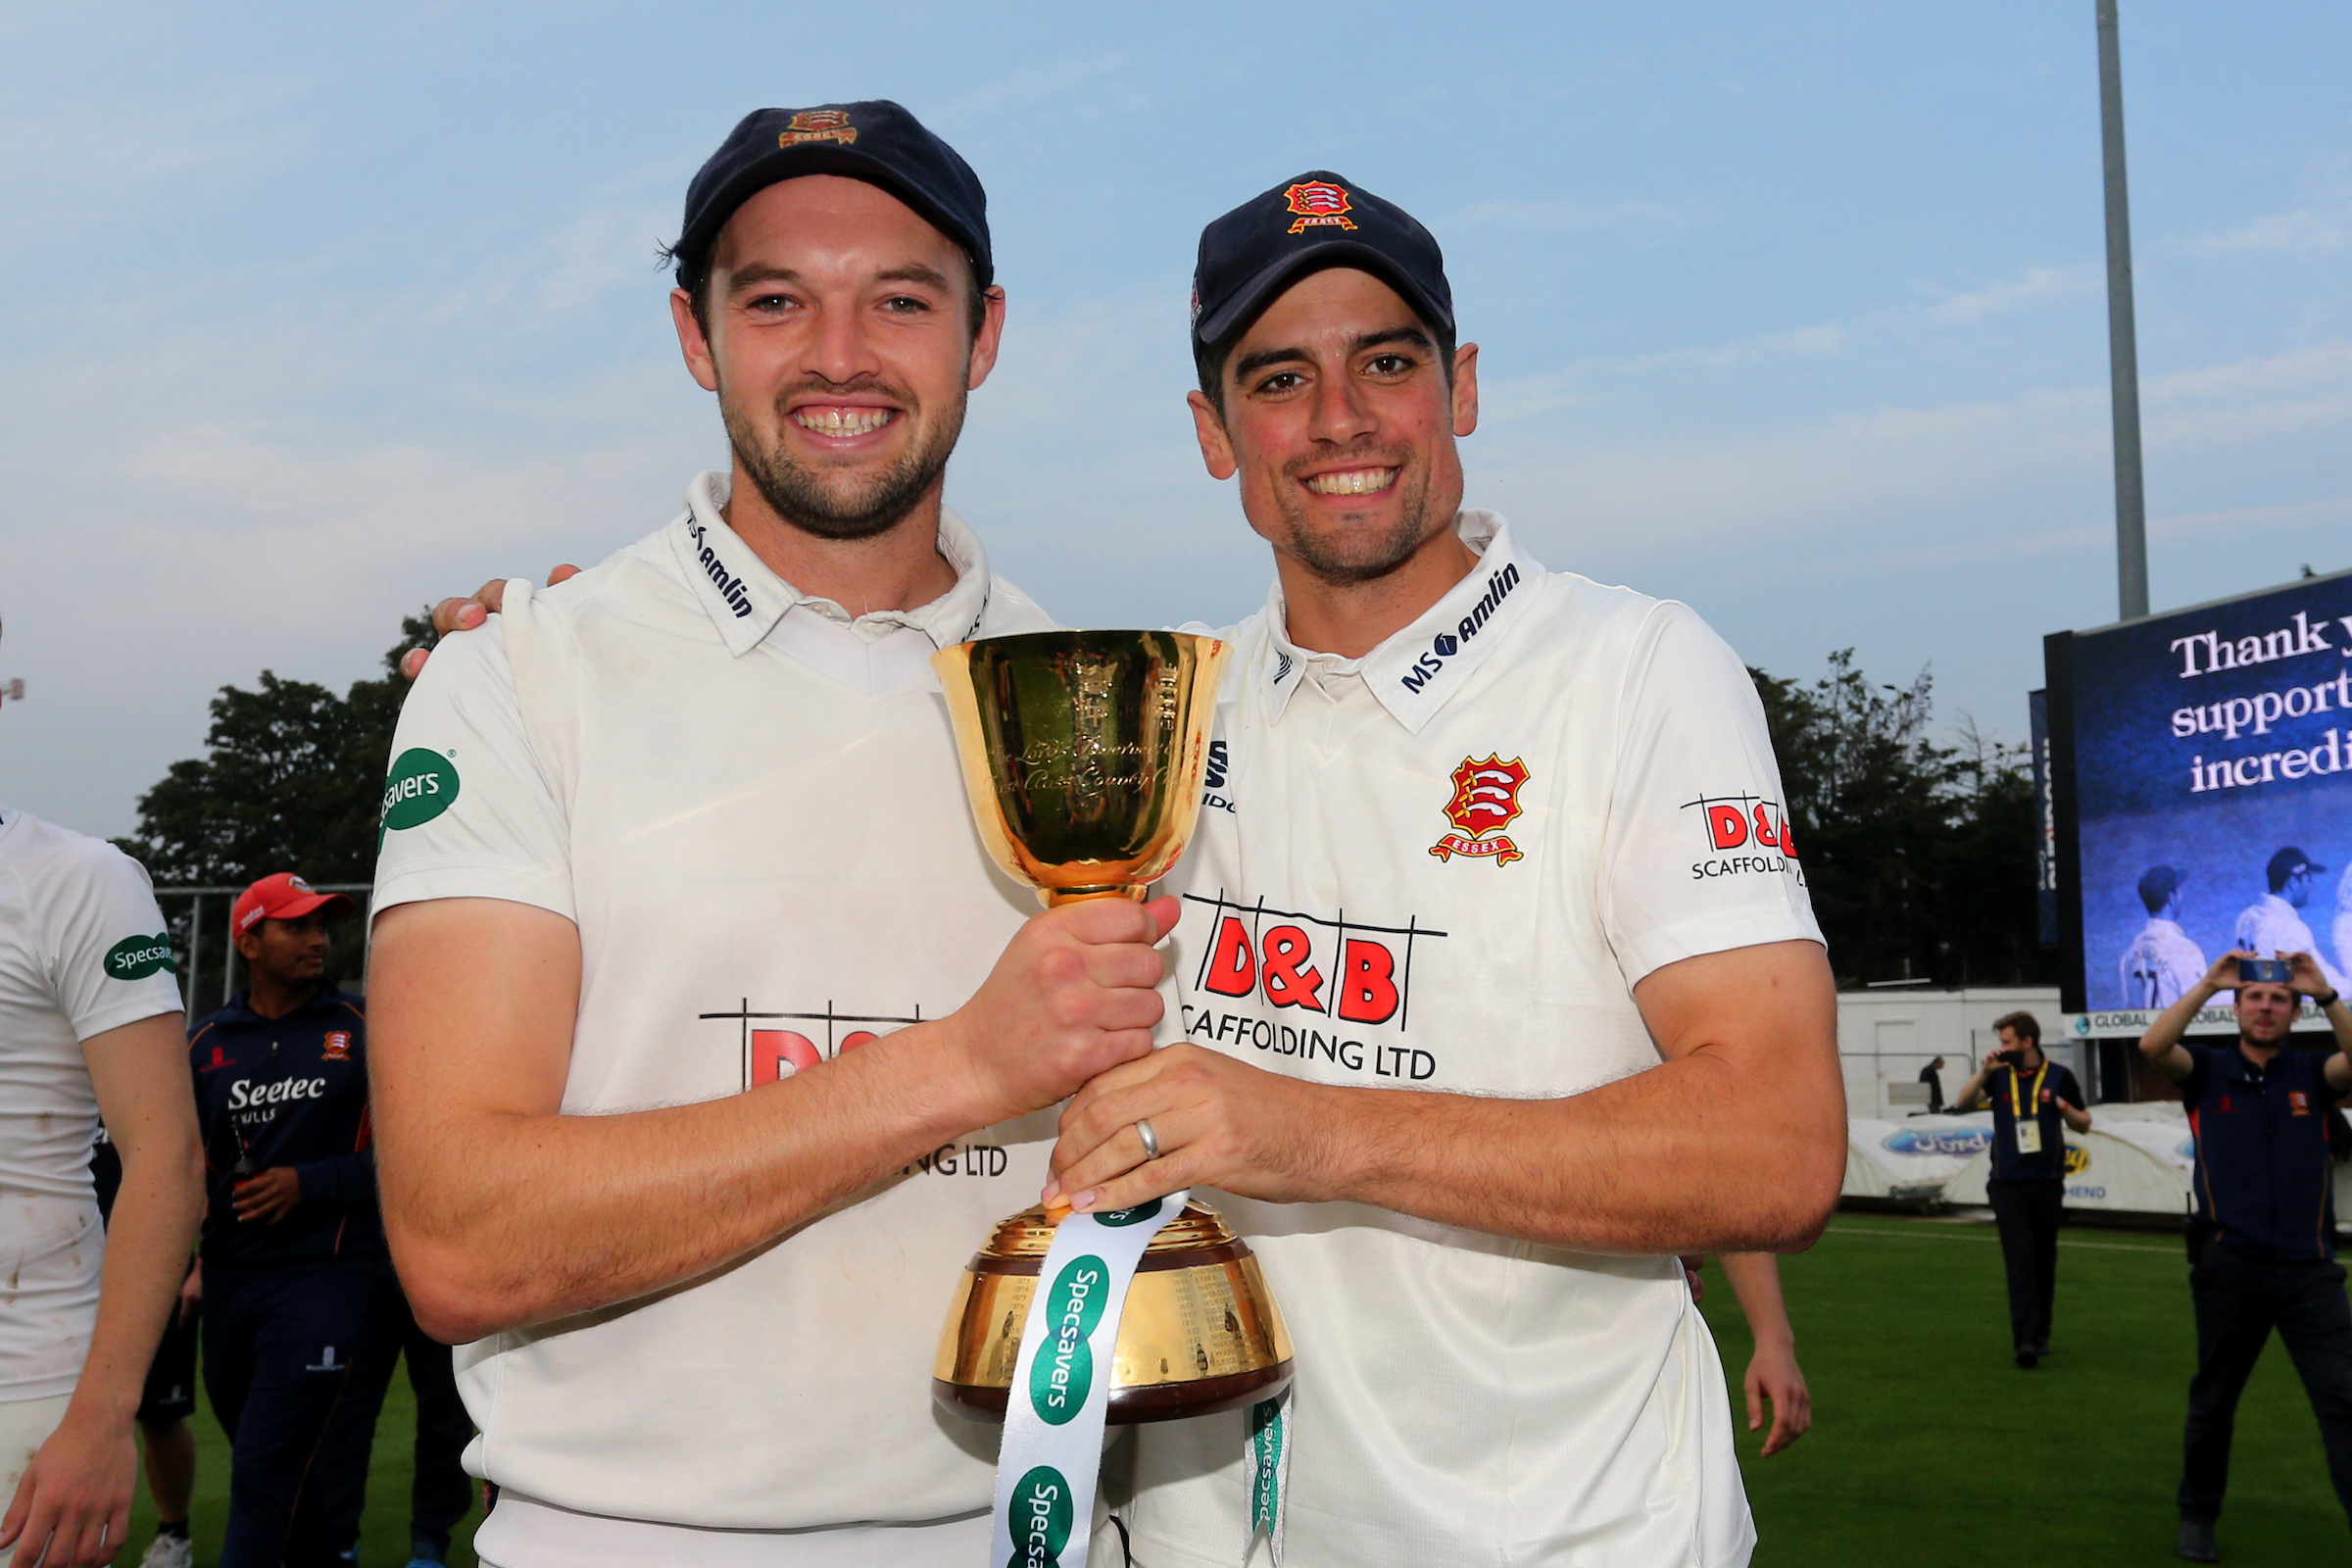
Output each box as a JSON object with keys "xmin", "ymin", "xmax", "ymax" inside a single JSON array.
[{"xmin": 0, "ymin": 807, "xmax": 181, "ymax": 1403}]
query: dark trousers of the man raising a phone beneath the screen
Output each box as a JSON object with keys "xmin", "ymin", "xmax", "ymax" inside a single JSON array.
[{"xmin": 2180, "ymin": 1242, "xmax": 2352, "ymax": 1523}]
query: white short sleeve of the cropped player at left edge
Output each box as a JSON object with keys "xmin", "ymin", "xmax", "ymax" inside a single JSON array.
[{"xmin": 37, "ymin": 837, "xmax": 186, "ymax": 1039}]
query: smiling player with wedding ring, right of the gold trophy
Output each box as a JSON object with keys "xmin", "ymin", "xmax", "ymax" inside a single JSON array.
[{"xmin": 1045, "ymin": 172, "xmax": 1844, "ymax": 1568}]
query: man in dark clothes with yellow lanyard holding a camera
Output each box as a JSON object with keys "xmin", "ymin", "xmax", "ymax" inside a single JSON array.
[{"xmin": 1952, "ymin": 1013, "xmax": 2091, "ymax": 1371}]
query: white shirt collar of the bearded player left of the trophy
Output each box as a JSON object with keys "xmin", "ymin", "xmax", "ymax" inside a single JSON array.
[{"xmin": 670, "ymin": 470, "xmax": 990, "ymax": 659}]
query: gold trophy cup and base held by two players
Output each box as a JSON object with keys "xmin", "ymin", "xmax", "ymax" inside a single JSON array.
[{"xmin": 931, "ymin": 632, "xmax": 1292, "ymax": 1425}]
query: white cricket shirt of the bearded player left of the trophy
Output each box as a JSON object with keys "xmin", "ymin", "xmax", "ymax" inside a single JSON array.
[{"xmin": 376, "ymin": 475, "xmax": 1054, "ymax": 1568}]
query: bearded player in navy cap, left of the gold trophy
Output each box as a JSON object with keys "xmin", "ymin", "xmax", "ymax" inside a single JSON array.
[{"xmin": 368, "ymin": 101, "xmax": 1174, "ymax": 1568}]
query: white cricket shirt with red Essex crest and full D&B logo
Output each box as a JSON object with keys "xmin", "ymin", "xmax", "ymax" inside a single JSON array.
[{"xmin": 1127, "ymin": 513, "xmax": 1821, "ymax": 1568}]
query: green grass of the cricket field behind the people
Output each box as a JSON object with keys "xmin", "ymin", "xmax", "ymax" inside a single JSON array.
[{"xmin": 118, "ymin": 1215, "xmax": 2352, "ymax": 1568}]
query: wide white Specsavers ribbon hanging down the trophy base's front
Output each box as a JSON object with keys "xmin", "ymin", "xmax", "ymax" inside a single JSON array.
[{"xmin": 988, "ymin": 1192, "xmax": 1186, "ymax": 1568}]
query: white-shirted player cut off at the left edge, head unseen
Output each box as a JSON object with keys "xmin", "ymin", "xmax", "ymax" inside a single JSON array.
[{"xmin": 0, "ymin": 807, "xmax": 205, "ymax": 1568}]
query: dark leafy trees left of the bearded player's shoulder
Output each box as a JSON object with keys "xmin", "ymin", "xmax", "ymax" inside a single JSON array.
[{"xmin": 118, "ymin": 615, "xmax": 433, "ymax": 992}]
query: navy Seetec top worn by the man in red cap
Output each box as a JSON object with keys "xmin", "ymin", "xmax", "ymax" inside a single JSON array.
[{"xmin": 188, "ymin": 990, "xmax": 386, "ymax": 1269}]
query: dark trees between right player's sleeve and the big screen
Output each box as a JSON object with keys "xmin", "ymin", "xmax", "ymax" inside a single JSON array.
[{"xmin": 1750, "ymin": 649, "xmax": 2051, "ymax": 985}]
